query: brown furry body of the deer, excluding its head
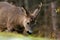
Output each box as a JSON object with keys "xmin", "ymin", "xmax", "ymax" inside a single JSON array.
[{"xmin": 0, "ymin": 2, "xmax": 26, "ymax": 31}]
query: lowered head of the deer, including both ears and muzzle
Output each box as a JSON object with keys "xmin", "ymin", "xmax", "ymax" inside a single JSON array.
[{"xmin": 24, "ymin": 3, "xmax": 42, "ymax": 33}]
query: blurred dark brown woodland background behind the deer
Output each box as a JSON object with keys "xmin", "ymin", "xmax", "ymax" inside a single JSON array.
[{"xmin": 0, "ymin": 0, "xmax": 60, "ymax": 38}]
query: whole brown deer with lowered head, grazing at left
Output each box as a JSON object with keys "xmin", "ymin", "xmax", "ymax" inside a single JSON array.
[{"xmin": 0, "ymin": 2, "xmax": 42, "ymax": 33}]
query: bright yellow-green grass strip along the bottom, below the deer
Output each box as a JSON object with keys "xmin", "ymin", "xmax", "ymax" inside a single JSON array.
[{"xmin": 0, "ymin": 32, "xmax": 55, "ymax": 40}]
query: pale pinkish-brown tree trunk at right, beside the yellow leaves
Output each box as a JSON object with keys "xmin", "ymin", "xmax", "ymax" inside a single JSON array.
[{"xmin": 51, "ymin": 2, "xmax": 57, "ymax": 38}]
